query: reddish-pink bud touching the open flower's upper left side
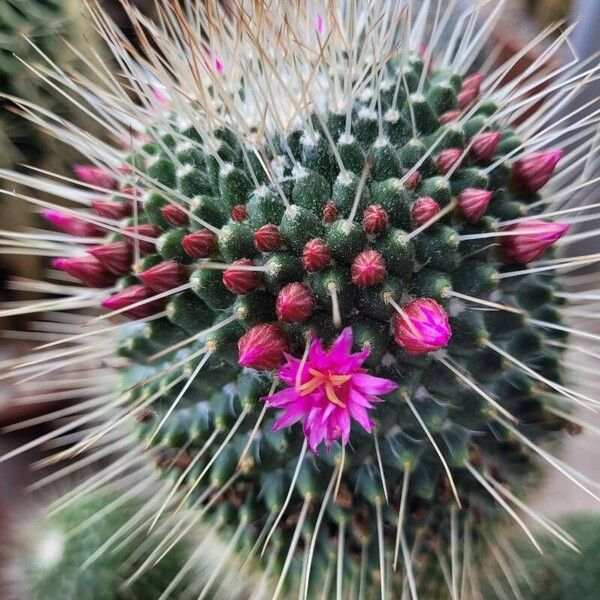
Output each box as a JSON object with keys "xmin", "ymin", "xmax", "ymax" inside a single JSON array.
[{"xmin": 238, "ymin": 323, "xmax": 287, "ymax": 371}]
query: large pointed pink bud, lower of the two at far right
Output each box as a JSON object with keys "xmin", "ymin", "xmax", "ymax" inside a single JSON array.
[{"xmin": 500, "ymin": 219, "xmax": 569, "ymax": 264}]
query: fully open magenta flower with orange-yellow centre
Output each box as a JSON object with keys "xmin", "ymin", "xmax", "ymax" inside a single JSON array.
[{"xmin": 266, "ymin": 327, "xmax": 398, "ymax": 452}]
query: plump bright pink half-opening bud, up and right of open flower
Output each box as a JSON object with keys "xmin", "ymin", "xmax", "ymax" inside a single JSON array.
[{"xmin": 394, "ymin": 298, "xmax": 452, "ymax": 354}]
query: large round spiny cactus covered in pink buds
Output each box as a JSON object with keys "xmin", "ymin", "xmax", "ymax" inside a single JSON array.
[{"xmin": 1, "ymin": 0, "xmax": 598, "ymax": 598}]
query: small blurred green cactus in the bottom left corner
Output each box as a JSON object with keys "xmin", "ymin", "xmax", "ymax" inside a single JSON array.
[{"xmin": 11, "ymin": 490, "xmax": 191, "ymax": 600}]
